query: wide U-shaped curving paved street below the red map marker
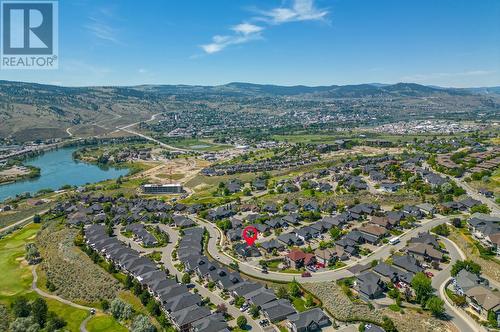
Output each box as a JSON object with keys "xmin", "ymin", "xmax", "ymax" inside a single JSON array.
[{"xmin": 192, "ymin": 216, "xmax": 449, "ymax": 282}]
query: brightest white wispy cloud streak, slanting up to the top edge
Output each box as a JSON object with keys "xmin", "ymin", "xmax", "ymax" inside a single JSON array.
[{"xmin": 197, "ymin": 0, "xmax": 328, "ymax": 58}]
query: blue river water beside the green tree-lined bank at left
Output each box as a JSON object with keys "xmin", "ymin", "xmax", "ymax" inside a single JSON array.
[{"xmin": 0, "ymin": 148, "xmax": 128, "ymax": 202}]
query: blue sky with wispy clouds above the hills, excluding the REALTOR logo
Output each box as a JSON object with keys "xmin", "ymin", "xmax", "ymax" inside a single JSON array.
[{"xmin": 0, "ymin": 0, "xmax": 500, "ymax": 87}]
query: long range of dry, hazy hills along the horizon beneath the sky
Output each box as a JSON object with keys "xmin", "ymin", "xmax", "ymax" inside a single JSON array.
[{"xmin": 0, "ymin": 80, "xmax": 500, "ymax": 141}]
